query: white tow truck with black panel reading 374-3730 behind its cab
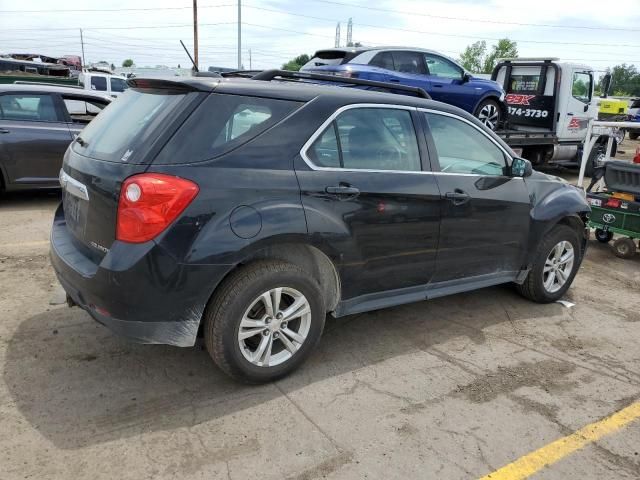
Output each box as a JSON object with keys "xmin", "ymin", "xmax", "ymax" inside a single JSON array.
[{"xmin": 491, "ymin": 58, "xmax": 617, "ymax": 174}]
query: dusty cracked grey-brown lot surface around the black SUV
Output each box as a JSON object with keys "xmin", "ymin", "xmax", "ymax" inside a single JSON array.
[{"xmin": 0, "ymin": 142, "xmax": 640, "ymax": 480}]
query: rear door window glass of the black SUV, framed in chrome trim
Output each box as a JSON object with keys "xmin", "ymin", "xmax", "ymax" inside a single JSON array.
[{"xmin": 308, "ymin": 108, "xmax": 421, "ymax": 172}]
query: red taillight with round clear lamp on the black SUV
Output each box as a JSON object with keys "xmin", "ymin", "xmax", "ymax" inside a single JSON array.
[{"xmin": 116, "ymin": 173, "xmax": 199, "ymax": 243}]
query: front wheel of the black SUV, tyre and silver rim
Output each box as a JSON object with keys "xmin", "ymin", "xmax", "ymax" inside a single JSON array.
[{"xmin": 518, "ymin": 225, "xmax": 581, "ymax": 303}]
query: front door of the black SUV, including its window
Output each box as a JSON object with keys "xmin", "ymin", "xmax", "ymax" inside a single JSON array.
[{"xmin": 422, "ymin": 110, "xmax": 530, "ymax": 282}]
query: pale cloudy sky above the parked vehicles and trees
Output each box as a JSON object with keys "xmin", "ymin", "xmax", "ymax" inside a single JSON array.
[{"xmin": 0, "ymin": 0, "xmax": 640, "ymax": 70}]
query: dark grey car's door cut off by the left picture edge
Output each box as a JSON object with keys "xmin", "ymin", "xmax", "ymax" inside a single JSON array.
[{"xmin": 0, "ymin": 92, "xmax": 72, "ymax": 188}]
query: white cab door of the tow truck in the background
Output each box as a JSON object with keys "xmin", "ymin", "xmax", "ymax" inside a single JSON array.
[{"xmin": 558, "ymin": 68, "xmax": 597, "ymax": 140}]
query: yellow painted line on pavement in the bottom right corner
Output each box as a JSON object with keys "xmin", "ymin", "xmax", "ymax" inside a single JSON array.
[{"xmin": 480, "ymin": 402, "xmax": 640, "ymax": 480}]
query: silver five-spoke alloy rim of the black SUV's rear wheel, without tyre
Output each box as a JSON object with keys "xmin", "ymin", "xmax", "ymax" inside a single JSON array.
[{"xmin": 238, "ymin": 287, "xmax": 311, "ymax": 367}]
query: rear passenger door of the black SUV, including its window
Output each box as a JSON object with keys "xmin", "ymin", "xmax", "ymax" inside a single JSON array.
[{"xmin": 295, "ymin": 105, "xmax": 440, "ymax": 300}]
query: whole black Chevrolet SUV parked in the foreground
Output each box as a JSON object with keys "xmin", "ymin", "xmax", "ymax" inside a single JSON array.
[{"xmin": 51, "ymin": 74, "xmax": 589, "ymax": 382}]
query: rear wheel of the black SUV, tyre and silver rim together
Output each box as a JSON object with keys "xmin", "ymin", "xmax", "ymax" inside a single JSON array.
[{"xmin": 204, "ymin": 261, "xmax": 325, "ymax": 383}]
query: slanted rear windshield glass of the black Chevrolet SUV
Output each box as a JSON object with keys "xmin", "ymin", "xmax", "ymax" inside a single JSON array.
[{"xmin": 73, "ymin": 88, "xmax": 186, "ymax": 163}]
